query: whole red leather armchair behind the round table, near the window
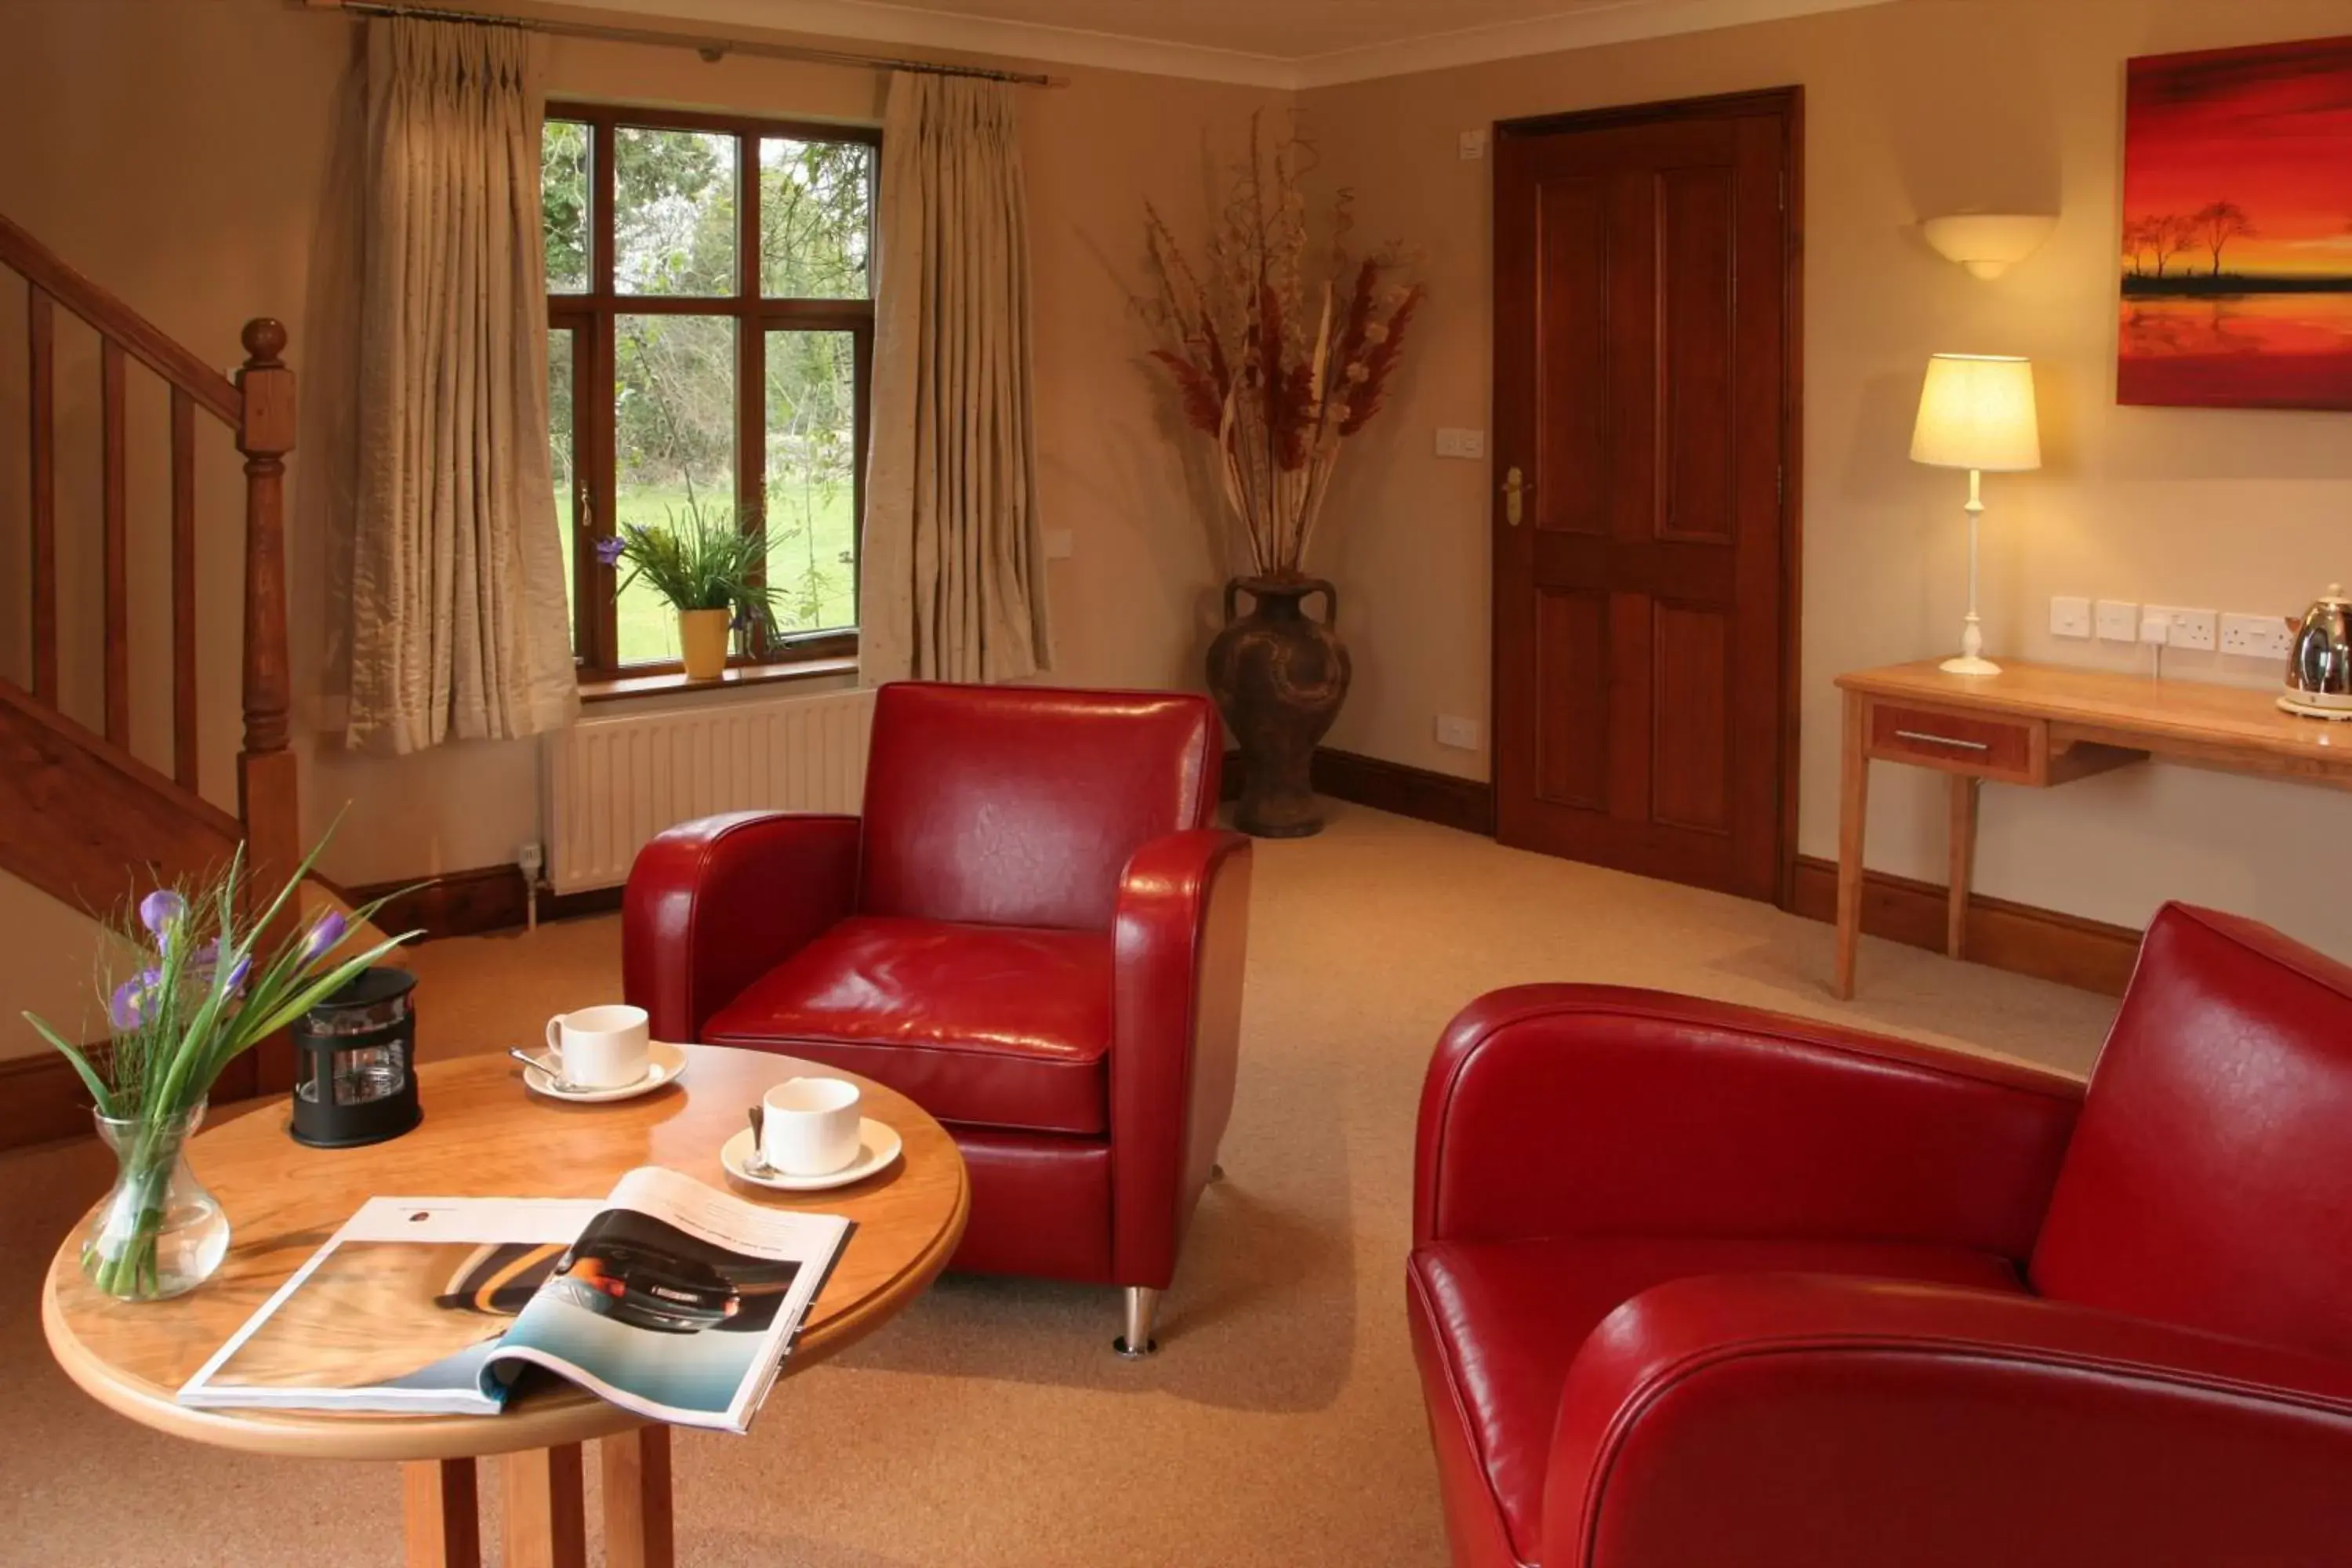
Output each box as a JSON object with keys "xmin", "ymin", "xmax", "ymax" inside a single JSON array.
[{"xmin": 621, "ymin": 682, "xmax": 1249, "ymax": 1354}]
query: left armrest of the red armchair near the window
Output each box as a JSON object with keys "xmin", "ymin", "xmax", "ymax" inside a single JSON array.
[{"xmin": 621, "ymin": 811, "xmax": 861, "ymax": 1041}]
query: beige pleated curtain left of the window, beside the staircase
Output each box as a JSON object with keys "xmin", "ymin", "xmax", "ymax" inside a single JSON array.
[{"xmin": 346, "ymin": 19, "xmax": 579, "ymax": 753}]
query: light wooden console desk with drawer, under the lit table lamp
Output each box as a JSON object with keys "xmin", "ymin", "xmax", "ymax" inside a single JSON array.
[{"xmin": 1837, "ymin": 661, "xmax": 2352, "ymax": 996}]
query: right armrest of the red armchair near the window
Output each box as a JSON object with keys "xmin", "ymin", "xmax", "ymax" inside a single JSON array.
[{"xmin": 1110, "ymin": 827, "xmax": 1249, "ymax": 1288}]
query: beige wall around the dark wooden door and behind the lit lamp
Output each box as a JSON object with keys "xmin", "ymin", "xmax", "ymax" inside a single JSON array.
[{"xmin": 1305, "ymin": 0, "xmax": 2352, "ymax": 954}]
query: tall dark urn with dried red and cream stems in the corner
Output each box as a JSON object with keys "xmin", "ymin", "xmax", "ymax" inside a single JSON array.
[{"xmin": 1138, "ymin": 118, "xmax": 1423, "ymax": 839}]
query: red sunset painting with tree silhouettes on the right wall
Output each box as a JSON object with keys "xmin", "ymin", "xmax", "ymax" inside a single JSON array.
[{"xmin": 2117, "ymin": 38, "xmax": 2352, "ymax": 409}]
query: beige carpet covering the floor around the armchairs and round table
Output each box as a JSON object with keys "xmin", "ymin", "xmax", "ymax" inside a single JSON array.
[{"xmin": 0, "ymin": 806, "xmax": 2112, "ymax": 1568}]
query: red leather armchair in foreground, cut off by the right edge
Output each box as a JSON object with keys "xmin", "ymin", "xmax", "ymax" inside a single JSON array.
[{"xmin": 1406, "ymin": 905, "xmax": 2352, "ymax": 1568}]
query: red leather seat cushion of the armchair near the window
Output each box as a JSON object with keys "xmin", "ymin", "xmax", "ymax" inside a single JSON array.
[{"xmin": 703, "ymin": 916, "xmax": 1112, "ymax": 1135}]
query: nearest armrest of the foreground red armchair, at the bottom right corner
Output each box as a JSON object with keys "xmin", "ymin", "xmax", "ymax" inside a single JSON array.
[{"xmin": 1543, "ymin": 1274, "xmax": 2352, "ymax": 1568}]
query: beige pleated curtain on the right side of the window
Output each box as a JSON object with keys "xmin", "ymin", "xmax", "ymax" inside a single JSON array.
[{"xmin": 858, "ymin": 71, "xmax": 1051, "ymax": 684}]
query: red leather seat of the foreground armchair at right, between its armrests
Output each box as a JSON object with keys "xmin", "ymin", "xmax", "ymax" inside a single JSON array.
[{"xmin": 1406, "ymin": 1236, "xmax": 2023, "ymax": 1563}]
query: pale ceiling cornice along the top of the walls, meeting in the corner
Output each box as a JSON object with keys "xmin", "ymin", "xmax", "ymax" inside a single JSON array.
[{"xmin": 546, "ymin": 0, "xmax": 1891, "ymax": 89}]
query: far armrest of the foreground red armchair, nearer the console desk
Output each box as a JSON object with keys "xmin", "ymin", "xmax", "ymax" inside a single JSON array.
[{"xmin": 1414, "ymin": 985, "xmax": 2082, "ymax": 1258}]
